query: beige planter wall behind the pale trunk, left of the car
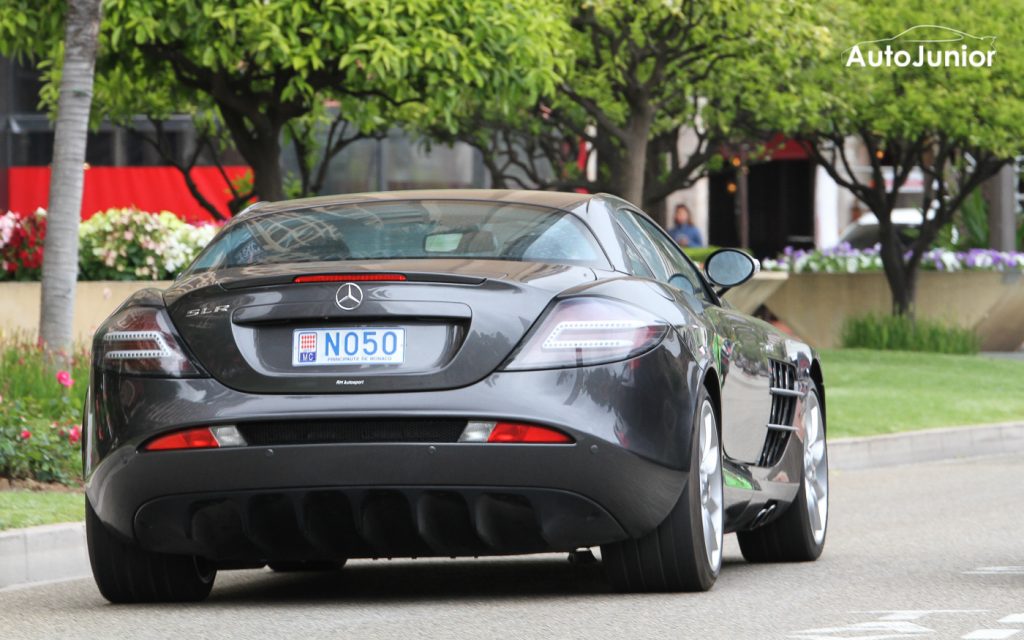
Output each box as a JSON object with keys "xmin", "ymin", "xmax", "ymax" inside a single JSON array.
[{"xmin": 0, "ymin": 281, "xmax": 171, "ymax": 340}]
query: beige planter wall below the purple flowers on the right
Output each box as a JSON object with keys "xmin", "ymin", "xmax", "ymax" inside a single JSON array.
[{"xmin": 765, "ymin": 271, "xmax": 1024, "ymax": 351}]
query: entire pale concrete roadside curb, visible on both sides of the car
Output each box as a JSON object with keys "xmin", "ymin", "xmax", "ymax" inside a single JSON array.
[{"xmin": 0, "ymin": 422, "xmax": 1024, "ymax": 590}]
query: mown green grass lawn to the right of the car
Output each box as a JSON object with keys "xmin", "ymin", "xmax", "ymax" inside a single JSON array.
[{"xmin": 821, "ymin": 349, "xmax": 1024, "ymax": 437}]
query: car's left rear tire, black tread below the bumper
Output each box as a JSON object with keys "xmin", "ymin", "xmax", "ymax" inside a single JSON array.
[{"xmin": 85, "ymin": 499, "xmax": 217, "ymax": 604}]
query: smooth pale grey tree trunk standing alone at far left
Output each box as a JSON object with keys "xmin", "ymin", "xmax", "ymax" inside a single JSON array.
[{"xmin": 39, "ymin": 0, "xmax": 101, "ymax": 359}]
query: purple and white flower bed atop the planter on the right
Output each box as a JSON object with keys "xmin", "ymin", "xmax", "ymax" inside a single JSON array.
[{"xmin": 761, "ymin": 243, "xmax": 1024, "ymax": 273}]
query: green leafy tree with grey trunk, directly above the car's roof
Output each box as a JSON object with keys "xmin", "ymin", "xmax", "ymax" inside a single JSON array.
[{"xmin": 430, "ymin": 0, "xmax": 824, "ymax": 215}]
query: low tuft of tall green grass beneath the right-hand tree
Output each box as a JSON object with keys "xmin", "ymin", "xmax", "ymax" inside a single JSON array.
[{"xmin": 842, "ymin": 313, "xmax": 981, "ymax": 353}]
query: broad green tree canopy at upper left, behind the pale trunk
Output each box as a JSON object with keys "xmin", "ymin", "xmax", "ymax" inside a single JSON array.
[{"xmin": 0, "ymin": 0, "xmax": 567, "ymax": 210}]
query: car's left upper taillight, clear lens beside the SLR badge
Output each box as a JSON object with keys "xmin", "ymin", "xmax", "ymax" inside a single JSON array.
[{"xmin": 99, "ymin": 307, "xmax": 200, "ymax": 378}]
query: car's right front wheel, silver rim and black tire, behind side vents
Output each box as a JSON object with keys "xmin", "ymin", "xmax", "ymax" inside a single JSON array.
[{"xmin": 736, "ymin": 386, "xmax": 828, "ymax": 562}]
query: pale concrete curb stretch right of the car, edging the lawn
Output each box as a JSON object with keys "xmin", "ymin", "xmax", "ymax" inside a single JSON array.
[{"xmin": 828, "ymin": 422, "xmax": 1024, "ymax": 471}]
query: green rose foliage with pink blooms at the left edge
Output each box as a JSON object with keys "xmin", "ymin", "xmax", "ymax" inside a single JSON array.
[{"xmin": 0, "ymin": 335, "xmax": 89, "ymax": 483}]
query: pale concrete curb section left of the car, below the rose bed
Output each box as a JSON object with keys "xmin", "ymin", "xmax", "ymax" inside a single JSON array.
[{"xmin": 0, "ymin": 522, "xmax": 90, "ymax": 589}]
